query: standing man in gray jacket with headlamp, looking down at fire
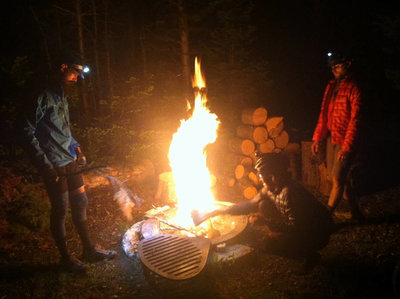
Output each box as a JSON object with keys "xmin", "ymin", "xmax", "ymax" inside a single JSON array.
[{"xmin": 24, "ymin": 53, "xmax": 116, "ymax": 272}]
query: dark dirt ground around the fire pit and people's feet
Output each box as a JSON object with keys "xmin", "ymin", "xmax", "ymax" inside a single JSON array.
[{"xmin": 0, "ymin": 173, "xmax": 400, "ymax": 299}]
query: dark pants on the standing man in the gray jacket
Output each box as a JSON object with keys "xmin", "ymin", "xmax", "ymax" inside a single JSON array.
[{"xmin": 45, "ymin": 162, "xmax": 92, "ymax": 257}]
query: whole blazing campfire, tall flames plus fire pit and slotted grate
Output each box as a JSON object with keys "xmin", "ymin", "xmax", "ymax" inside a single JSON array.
[{"xmin": 122, "ymin": 58, "xmax": 247, "ymax": 279}]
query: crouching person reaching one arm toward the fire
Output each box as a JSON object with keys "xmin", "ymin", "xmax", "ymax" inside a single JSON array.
[{"xmin": 193, "ymin": 153, "xmax": 334, "ymax": 272}]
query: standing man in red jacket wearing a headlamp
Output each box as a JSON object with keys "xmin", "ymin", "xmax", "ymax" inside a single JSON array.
[{"xmin": 311, "ymin": 53, "xmax": 364, "ymax": 221}]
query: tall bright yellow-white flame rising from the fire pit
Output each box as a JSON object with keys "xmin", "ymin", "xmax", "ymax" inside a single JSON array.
[{"xmin": 169, "ymin": 58, "xmax": 219, "ymax": 227}]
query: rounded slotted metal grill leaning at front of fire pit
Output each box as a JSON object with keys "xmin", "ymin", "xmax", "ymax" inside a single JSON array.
[{"xmin": 138, "ymin": 234, "xmax": 211, "ymax": 280}]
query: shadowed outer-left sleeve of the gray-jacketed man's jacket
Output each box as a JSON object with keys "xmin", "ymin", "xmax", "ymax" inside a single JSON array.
[{"xmin": 24, "ymin": 94, "xmax": 53, "ymax": 169}]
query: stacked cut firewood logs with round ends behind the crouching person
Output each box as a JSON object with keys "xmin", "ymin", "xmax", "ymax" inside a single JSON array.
[{"xmin": 226, "ymin": 107, "xmax": 289, "ymax": 199}]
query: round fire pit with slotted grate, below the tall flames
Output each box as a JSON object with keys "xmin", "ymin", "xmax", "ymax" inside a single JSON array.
[{"xmin": 122, "ymin": 202, "xmax": 251, "ymax": 280}]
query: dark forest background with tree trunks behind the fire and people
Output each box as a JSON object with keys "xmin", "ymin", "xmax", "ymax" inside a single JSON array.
[{"xmin": 0, "ymin": 0, "xmax": 400, "ymax": 169}]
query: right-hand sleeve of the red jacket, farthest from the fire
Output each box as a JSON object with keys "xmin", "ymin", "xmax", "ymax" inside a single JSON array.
[{"xmin": 342, "ymin": 85, "xmax": 361, "ymax": 151}]
